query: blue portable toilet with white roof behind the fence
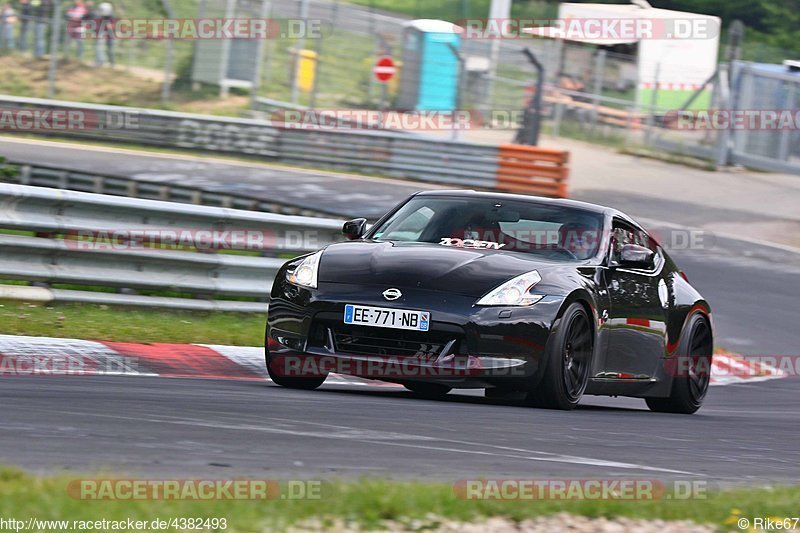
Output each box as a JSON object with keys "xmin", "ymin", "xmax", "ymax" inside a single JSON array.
[{"xmin": 397, "ymin": 19, "xmax": 461, "ymax": 111}]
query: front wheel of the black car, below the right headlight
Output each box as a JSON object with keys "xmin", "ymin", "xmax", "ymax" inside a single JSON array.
[{"xmin": 526, "ymin": 303, "xmax": 594, "ymax": 410}]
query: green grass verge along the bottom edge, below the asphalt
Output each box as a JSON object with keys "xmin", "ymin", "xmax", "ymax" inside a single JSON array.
[{"xmin": 0, "ymin": 468, "xmax": 800, "ymax": 532}]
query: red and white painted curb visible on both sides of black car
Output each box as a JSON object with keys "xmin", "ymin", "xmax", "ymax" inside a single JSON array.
[{"xmin": 0, "ymin": 335, "xmax": 787, "ymax": 386}]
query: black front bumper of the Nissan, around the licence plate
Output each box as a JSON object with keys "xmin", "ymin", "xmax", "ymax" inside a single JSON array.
[{"xmin": 267, "ymin": 278, "xmax": 563, "ymax": 390}]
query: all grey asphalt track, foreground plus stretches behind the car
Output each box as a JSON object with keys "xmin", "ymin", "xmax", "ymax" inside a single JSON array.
[{"xmin": 0, "ymin": 137, "xmax": 800, "ymax": 484}]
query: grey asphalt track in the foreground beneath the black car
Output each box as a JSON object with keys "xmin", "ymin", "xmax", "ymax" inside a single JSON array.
[{"xmin": 0, "ymin": 377, "xmax": 800, "ymax": 485}]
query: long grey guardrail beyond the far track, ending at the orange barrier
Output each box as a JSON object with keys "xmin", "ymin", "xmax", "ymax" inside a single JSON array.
[{"xmin": 0, "ymin": 96, "xmax": 568, "ymax": 195}]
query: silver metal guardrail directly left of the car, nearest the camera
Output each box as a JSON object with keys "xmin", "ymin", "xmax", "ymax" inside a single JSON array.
[{"xmin": 0, "ymin": 184, "xmax": 342, "ymax": 311}]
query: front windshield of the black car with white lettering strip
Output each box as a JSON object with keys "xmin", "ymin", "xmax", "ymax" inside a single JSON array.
[{"xmin": 370, "ymin": 196, "xmax": 603, "ymax": 261}]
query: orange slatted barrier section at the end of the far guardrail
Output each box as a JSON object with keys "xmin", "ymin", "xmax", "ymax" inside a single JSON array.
[{"xmin": 497, "ymin": 144, "xmax": 569, "ymax": 198}]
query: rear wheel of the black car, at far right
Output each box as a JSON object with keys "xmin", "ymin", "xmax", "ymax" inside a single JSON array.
[{"xmin": 645, "ymin": 314, "xmax": 714, "ymax": 415}]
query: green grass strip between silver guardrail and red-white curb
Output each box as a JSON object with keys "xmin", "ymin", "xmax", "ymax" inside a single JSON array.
[{"xmin": 0, "ymin": 302, "xmax": 266, "ymax": 342}]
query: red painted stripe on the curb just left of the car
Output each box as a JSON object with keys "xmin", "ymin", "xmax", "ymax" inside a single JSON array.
[{"xmin": 103, "ymin": 342, "xmax": 263, "ymax": 379}]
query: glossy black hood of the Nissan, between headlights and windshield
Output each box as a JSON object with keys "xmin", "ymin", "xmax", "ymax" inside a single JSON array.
[{"xmin": 319, "ymin": 241, "xmax": 564, "ymax": 298}]
